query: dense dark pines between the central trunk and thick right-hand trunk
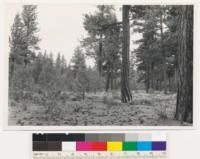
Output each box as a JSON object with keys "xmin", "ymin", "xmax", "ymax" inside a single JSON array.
[{"xmin": 132, "ymin": 6, "xmax": 177, "ymax": 93}]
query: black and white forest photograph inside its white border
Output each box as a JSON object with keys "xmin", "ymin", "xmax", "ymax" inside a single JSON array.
[{"xmin": 6, "ymin": 3, "xmax": 194, "ymax": 126}]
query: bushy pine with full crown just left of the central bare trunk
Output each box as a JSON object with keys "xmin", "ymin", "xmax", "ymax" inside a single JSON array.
[{"xmin": 82, "ymin": 5, "xmax": 122, "ymax": 91}]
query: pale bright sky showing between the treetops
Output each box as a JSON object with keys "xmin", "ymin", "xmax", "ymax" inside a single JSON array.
[{"xmin": 6, "ymin": 4, "xmax": 140, "ymax": 65}]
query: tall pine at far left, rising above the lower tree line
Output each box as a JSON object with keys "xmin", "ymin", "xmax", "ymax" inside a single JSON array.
[{"xmin": 9, "ymin": 5, "xmax": 39, "ymax": 94}]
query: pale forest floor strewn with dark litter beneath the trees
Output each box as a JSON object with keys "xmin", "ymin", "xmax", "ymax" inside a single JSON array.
[{"xmin": 8, "ymin": 91, "xmax": 190, "ymax": 126}]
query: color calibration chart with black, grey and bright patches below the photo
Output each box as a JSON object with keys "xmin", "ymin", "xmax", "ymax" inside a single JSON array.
[{"xmin": 32, "ymin": 133, "xmax": 167, "ymax": 159}]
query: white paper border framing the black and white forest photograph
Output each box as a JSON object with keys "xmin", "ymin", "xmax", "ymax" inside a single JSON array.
[{"xmin": 0, "ymin": 0, "xmax": 200, "ymax": 132}]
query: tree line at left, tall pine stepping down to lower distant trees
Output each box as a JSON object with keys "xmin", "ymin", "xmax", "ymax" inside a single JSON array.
[{"xmin": 9, "ymin": 5, "xmax": 104, "ymax": 99}]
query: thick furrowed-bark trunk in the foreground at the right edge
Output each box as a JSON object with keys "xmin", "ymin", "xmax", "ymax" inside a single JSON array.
[{"xmin": 175, "ymin": 6, "xmax": 193, "ymax": 123}]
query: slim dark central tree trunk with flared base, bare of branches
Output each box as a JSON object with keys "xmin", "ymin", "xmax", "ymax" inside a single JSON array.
[{"xmin": 121, "ymin": 5, "xmax": 132, "ymax": 103}]
